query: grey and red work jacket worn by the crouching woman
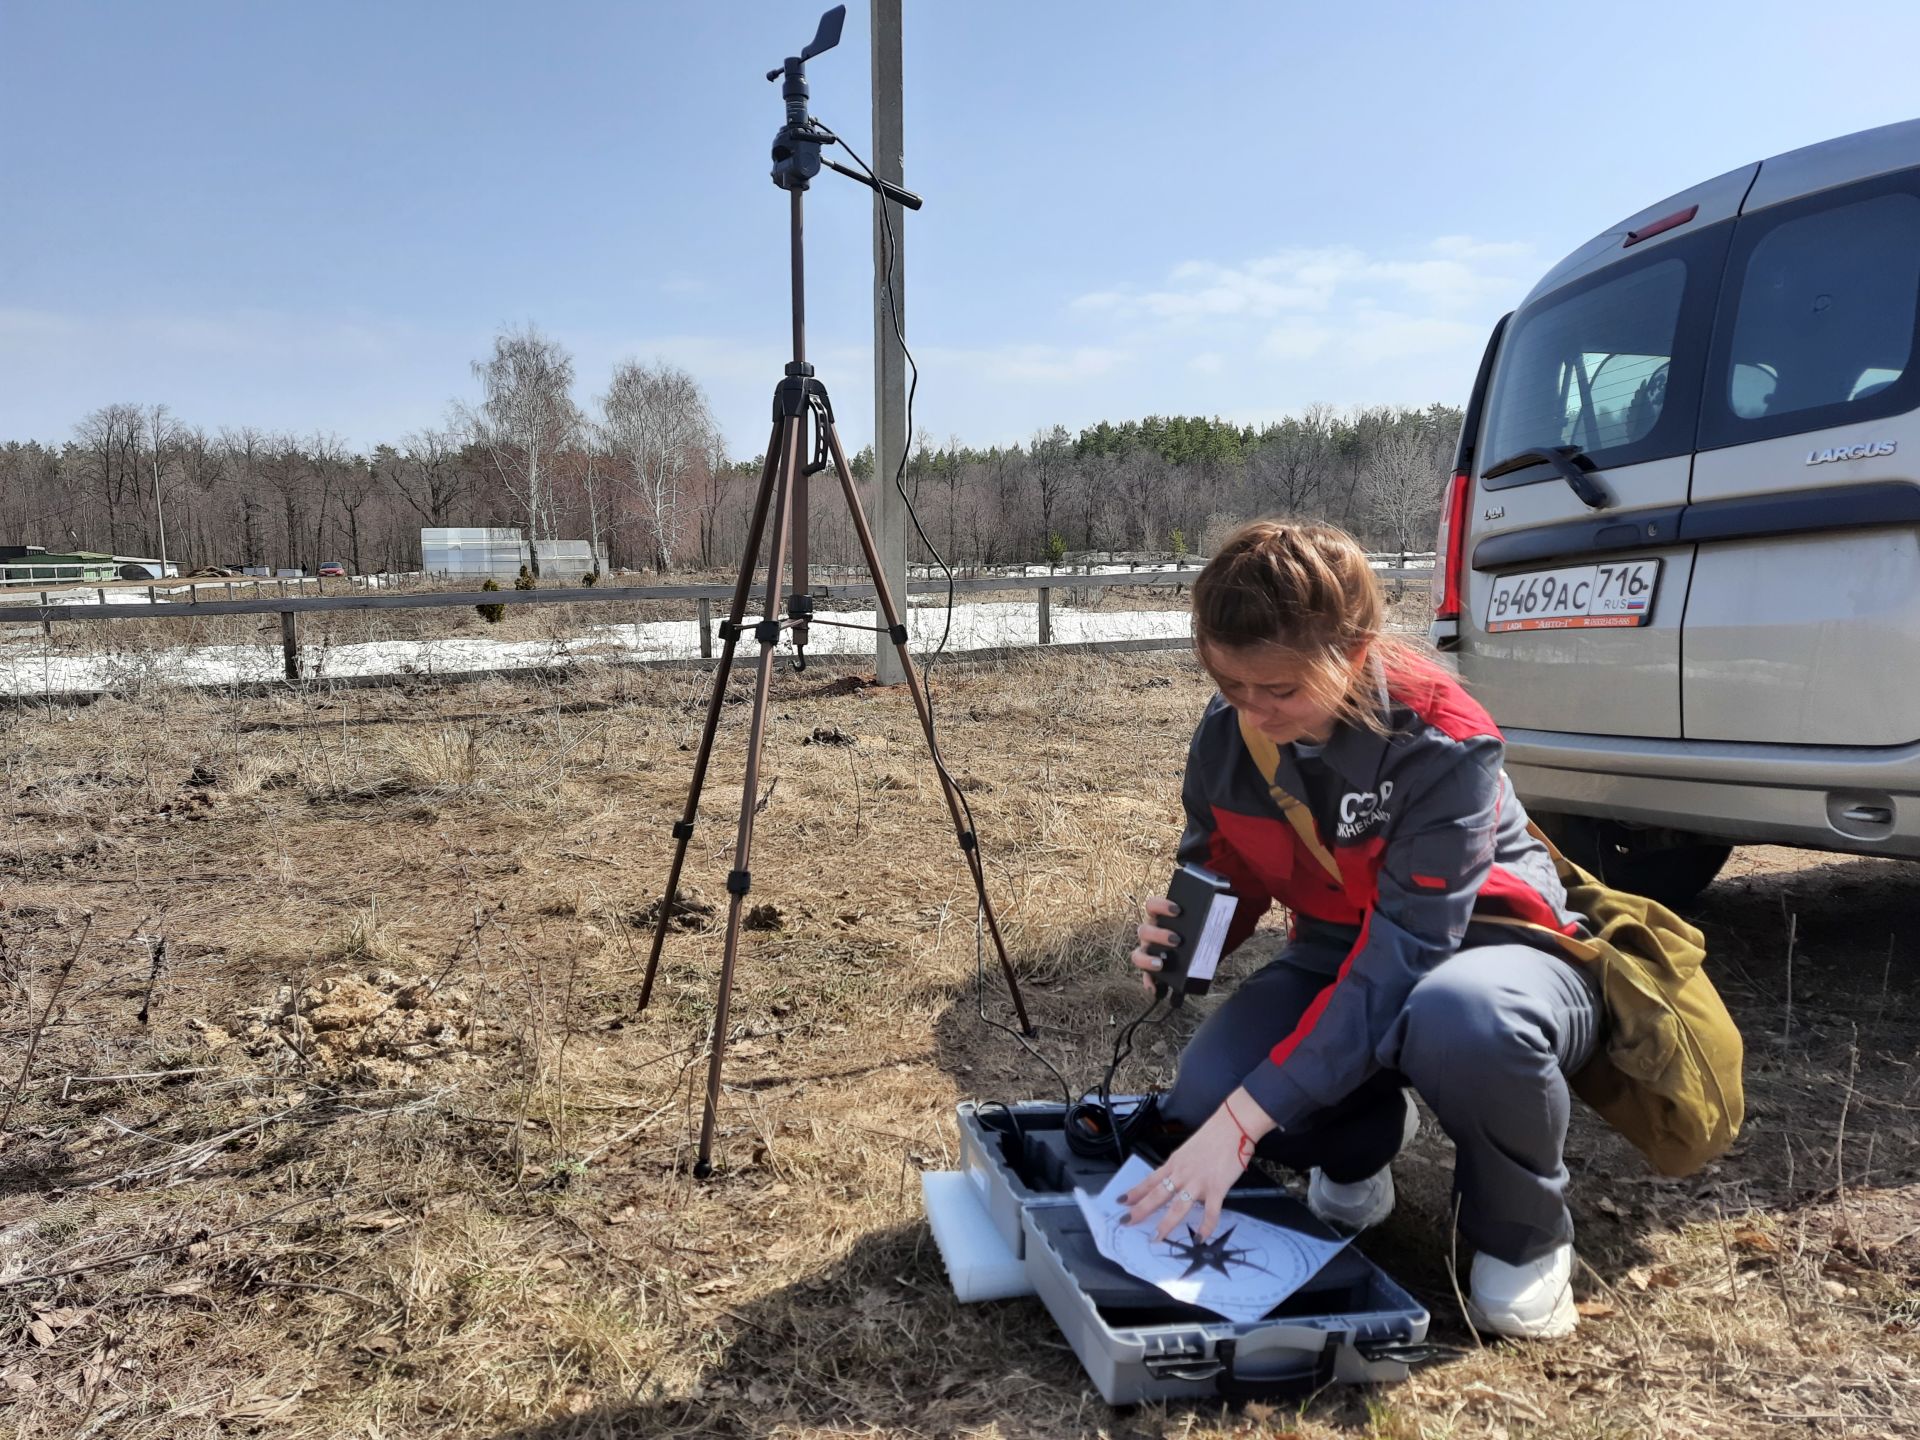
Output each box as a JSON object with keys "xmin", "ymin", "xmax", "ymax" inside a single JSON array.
[{"xmin": 1179, "ymin": 662, "xmax": 1580, "ymax": 1129}]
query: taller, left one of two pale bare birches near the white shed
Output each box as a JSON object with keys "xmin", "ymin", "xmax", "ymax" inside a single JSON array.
[{"xmin": 467, "ymin": 324, "xmax": 580, "ymax": 574}]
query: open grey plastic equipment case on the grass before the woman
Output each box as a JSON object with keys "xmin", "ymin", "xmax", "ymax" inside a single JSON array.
[{"xmin": 924, "ymin": 1096, "xmax": 1428, "ymax": 1405}]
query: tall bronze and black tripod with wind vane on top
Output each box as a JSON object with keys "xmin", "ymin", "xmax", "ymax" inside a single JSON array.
[{"xmin": 637, "ymin": 6, "xmax": 1035, "ymax": 1179}]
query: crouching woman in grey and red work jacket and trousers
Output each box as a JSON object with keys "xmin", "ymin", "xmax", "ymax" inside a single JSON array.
[{"xmin": 1127, "ymin": 520, "xmax": 1603, "ymax": 1336}]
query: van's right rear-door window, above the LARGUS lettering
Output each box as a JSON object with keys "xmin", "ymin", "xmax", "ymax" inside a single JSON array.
[{"xmin": 1726, "ymin": 194, "xmax": 1920, "ymax": 424}]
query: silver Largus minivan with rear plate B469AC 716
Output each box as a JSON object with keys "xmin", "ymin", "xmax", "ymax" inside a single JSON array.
[{"xmin": 1432, "ymin": 121, "xmax": 1920, "ymax": 902}]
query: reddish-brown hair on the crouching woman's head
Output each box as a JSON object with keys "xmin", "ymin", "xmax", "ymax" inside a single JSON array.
[{"xmin": 1192, "ymin": 518, "xmax": 1427, "ymax": 732}]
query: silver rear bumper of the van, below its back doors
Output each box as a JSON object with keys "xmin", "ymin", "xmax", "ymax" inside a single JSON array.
[{"xmin": 1505, "ymin": 730, "xmax": 1920, "ymax": 858}]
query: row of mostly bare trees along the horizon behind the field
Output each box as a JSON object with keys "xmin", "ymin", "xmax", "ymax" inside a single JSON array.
[{"xmin": 0, "ymin": 326, "xmax": 1459, "ymax": 572}]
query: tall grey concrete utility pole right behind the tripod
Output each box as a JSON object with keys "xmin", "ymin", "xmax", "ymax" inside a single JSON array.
[{"xmin": 872, "ymin": 0, "xmax": 912, "ymax": 685}]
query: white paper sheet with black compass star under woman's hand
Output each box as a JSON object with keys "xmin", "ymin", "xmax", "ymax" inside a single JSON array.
[{"xmin": 1073, "ymin": 1156, "xmax": 1346, "ymax": 1321}]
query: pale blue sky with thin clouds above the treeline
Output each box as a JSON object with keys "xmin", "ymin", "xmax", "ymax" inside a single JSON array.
[{"xmin": 0, "ymin": 0, "xmax": 1920, "ymax": 455}]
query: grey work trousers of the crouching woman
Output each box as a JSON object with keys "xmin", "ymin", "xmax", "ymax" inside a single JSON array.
[{"xmin": 1162, "ymin": 935, "xmax": 1603, "ymax": 1265}]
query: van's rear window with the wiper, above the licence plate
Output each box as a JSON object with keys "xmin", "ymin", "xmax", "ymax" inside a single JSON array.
[{"xmin": 1480, "ymin": 255, "xmax": 1697, "ymax": 482}]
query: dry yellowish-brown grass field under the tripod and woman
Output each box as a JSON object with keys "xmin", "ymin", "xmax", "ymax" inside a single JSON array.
[{"xmin": 0, "ymin": 652, "xmax": 1920, "ymax": 1440}]
